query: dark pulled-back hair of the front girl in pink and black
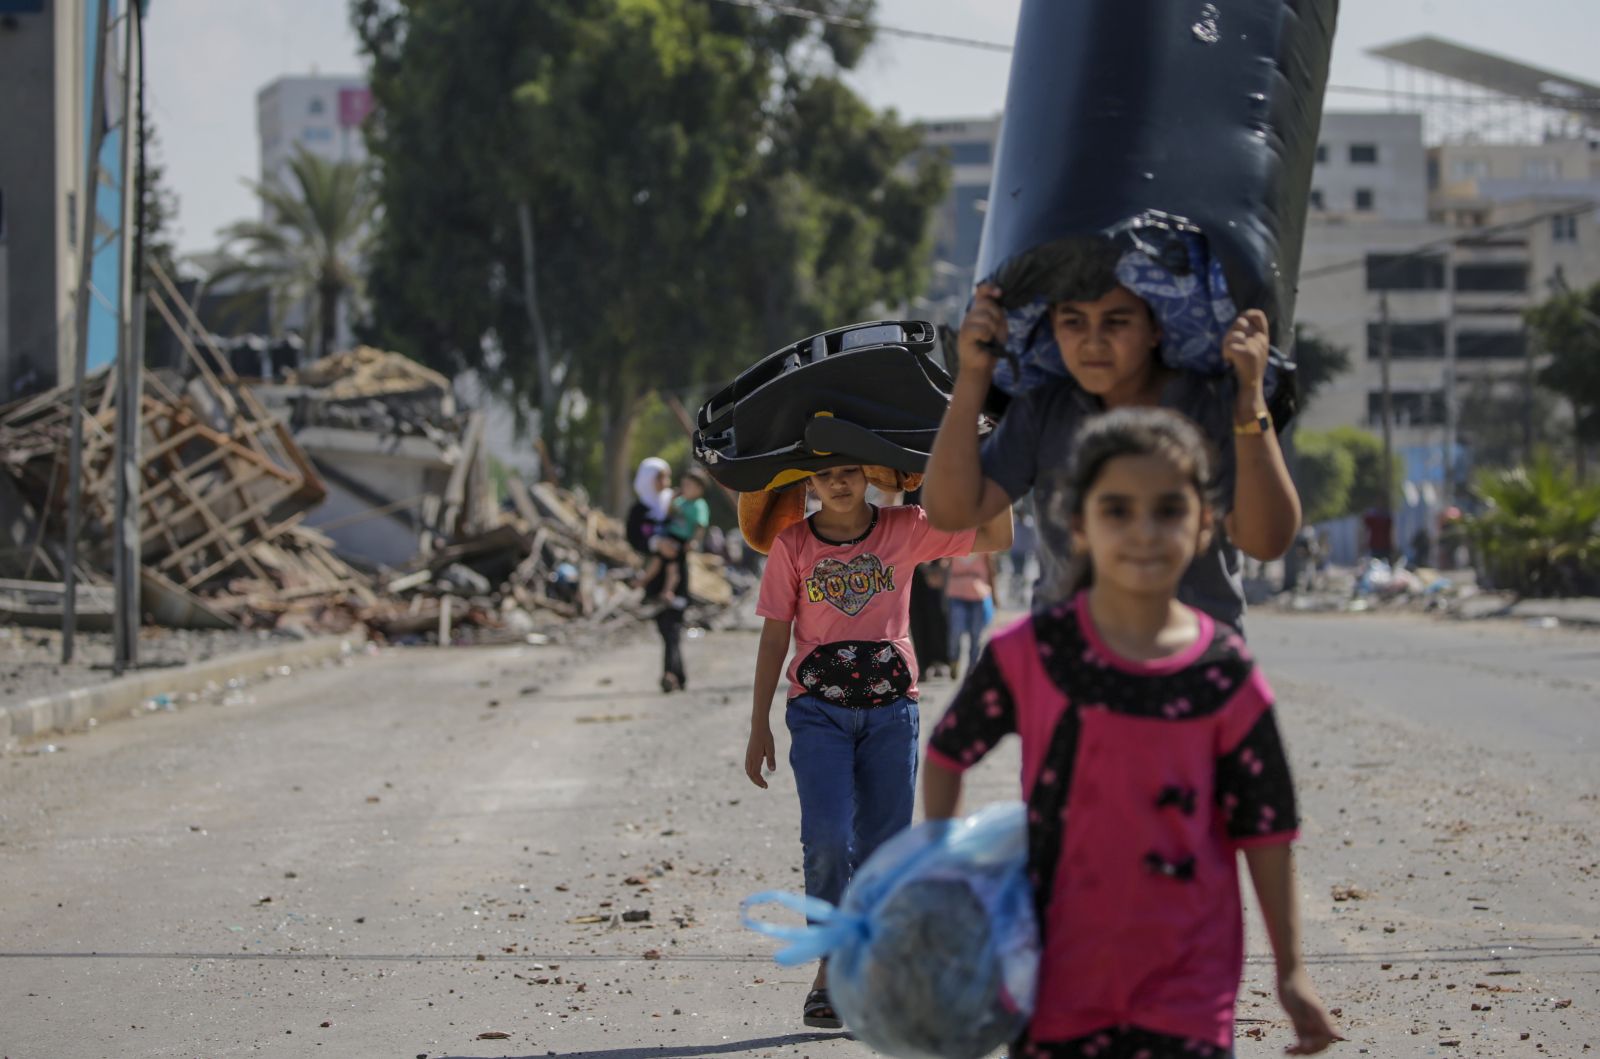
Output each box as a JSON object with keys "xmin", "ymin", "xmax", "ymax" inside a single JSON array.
[{"xmin": 1051, "ymin": 408, "xmax": 1213, "ymax": 595}]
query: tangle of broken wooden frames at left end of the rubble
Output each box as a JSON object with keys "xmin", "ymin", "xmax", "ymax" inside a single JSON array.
[{"xmin": 0, "ymin": 329, "xmax": 368, "ymax": 625}]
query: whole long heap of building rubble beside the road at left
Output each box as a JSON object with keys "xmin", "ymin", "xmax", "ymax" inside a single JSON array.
[{"xmin": 0, "ymin": 327, "xmax": 733, "ymax": 641}]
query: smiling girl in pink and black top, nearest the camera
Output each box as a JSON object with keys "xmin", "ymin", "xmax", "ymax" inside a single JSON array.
[{"xmin": 923, "ymin": 410, "xmax": 1338, "ymax": 1059}]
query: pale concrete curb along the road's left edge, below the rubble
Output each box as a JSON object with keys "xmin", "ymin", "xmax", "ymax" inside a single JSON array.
[{"xmin": 0, "ymin": 633, "xmax": 366, "ymax": 744}]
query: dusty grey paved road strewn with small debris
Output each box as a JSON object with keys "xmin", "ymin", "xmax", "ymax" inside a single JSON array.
[{"xmin": 0, "ymin": 614, "xmax": 1600, "ymax": 1059}]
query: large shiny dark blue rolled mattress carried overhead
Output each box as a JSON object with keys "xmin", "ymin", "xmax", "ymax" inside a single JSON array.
[{"xmin": 978, "ymin": 0, "xmax": 1339, "ymax": 422}]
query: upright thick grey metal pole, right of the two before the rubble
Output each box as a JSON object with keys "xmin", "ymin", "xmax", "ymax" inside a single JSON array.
[{"xmin": 112, "ymin": 3, "xmax": 144, "ymax": 677}]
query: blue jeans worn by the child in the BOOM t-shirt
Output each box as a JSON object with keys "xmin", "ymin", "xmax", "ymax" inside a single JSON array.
[{"xmin": 784, "ymin": 694, "xmax": 922, "ymax": 904}]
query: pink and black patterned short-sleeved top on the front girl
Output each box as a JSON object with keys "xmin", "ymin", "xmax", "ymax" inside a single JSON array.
[{"xmin": 928, "ymin": 593, "xmax": 1298, "ymax": 1054}]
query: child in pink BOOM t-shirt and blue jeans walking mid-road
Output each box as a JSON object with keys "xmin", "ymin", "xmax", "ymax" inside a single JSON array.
[{"xmin": 741, "ymin": 466, "xmax": 1011, "ymax": 1029}]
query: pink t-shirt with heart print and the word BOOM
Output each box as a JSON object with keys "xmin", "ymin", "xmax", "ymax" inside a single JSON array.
[{"xmin": 755, "ymin": 504, "xmax": 978, "ymax": 699}]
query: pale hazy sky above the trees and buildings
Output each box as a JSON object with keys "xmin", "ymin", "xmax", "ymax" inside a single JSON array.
[{"xmin": 147, "ymin": 0, "xmax": 1600, "ymax": 251}]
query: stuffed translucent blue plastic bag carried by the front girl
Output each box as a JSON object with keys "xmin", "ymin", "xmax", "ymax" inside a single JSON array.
[{"xmin": 744, "ymin": 801, "xmax": 1038, "ymax": 1059}]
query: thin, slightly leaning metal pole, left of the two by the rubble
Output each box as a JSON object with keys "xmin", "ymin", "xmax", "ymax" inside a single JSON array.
[{"xmin": 61, "ymin": 0, "xmax": 110, "ymax": 664}]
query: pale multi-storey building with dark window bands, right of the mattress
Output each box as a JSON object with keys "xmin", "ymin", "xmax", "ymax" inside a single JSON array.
[{"xmin": 1298, "ymin": 114, "xmax": 1600, "ymax": 448}]
